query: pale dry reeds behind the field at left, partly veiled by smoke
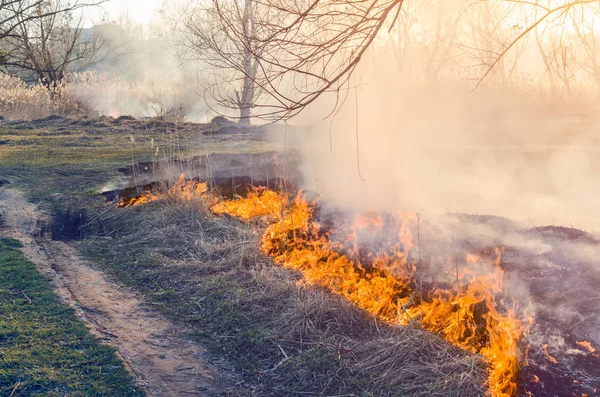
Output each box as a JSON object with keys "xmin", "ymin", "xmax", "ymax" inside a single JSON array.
[{"xmin": 0, "ymin": 72, "xmax": 201, "ymax": 120}]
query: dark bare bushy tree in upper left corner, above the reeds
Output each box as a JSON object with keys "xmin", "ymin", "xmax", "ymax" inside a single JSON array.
[{"xmin": 0, "ymin": 0, "xmax": 99, "ymax": 87}]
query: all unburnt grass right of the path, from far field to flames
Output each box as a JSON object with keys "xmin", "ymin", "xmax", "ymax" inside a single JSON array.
[{"xmin": 0, "ymin": 119, "xmax": 486, "ymax": 397}]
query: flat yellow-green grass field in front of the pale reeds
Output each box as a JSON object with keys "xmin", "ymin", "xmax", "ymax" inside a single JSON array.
[{"xmin": 0, "ymin": 118, "xmax": 271, "ymax": 212}]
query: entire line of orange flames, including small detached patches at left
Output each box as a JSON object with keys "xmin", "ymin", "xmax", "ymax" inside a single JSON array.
[{"xmin": 119, "ymin": 180, "xmax": 532, "ymax": 397}]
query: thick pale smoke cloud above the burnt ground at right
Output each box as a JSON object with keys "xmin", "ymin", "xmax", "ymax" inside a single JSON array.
[{"xmin": 288, "ymin": 52, "xmax": 600, "ymax": 229}]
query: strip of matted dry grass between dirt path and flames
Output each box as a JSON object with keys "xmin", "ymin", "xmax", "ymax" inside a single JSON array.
[{"xmin": 87, "ymin": 198, "xmax": 486, "ymax": 396}]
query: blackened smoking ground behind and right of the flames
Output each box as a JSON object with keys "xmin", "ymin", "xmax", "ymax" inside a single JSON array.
[{"xmin": 315, "ymin": 206, "xmax": 600, "ymax": 397}]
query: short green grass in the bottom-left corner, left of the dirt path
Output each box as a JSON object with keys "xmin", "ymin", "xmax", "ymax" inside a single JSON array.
[{"xmin": 0, "ymin": 238, "xmax": 144, "ymax": 396}]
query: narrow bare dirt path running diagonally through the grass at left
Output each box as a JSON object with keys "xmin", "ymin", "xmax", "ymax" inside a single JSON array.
[{"xmin": 0, "ymin": 188, "xmax": 250, "ymax": 396}]
